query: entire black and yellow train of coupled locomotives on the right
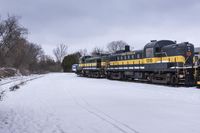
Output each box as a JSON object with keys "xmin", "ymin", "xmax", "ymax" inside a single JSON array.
[{"xmin": 76, "ymin": 40, "xmax": 200, "ymax": 86}]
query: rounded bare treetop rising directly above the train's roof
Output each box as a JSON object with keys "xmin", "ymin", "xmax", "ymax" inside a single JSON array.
[{"xmin": 107, "ymin": 40, "xmax": 128, "ymax": 53}]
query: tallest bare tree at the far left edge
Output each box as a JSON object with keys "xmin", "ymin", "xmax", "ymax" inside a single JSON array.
[{"xmin": 0, "ymin": 15, "xmax": 28, "ymax": 67}]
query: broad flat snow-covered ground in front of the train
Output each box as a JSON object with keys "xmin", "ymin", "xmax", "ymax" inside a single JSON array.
[{"xmin": 0, "ymin": 73, "xmax": 200, "ymax": 133}]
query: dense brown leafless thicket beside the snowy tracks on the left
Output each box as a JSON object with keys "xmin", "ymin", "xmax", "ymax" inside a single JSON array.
[{"xmin": 0, "ymin": 15, "xmax": 61, "ymax": 74}]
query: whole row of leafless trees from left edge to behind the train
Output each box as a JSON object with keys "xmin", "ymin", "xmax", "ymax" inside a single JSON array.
[{"xmin": 0, "ymin": 15, "xmax": 131, "ymax": 74}]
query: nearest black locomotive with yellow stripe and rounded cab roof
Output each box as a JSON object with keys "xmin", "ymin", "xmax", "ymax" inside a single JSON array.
[{"xmin": 106, "ymin": 40, "xmax": 194, "ymax": 86}]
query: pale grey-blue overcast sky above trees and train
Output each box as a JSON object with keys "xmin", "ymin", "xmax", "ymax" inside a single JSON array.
[{"xmin": 0, "ymin": 0, "xmax": 200, "ymax": 54}]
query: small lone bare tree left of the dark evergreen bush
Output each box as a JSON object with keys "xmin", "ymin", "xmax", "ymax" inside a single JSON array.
[{"xmin": 53, "ymin": 44, "xmax": 68, "ymax": 63}]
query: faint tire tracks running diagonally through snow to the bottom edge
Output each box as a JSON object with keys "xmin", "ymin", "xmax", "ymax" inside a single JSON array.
[{"xmin": 68, "ymin": 89, "xmax": 139, "ymax": 133}]
